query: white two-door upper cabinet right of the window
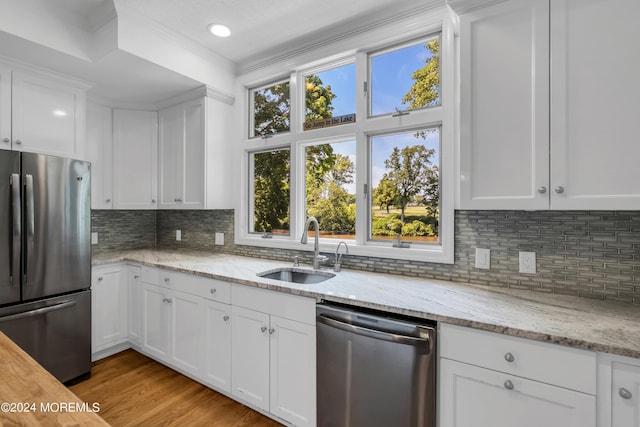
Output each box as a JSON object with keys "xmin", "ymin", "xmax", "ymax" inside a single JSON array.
[{"xmin": 458, "ymin": 0, "xmax": 640, "ymax": 210}]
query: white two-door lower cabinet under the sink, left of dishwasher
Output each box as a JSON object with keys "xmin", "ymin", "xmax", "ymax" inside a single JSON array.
[{"xmin": 231, "ymin": 285, "xmax": 316, "ymax": 426}]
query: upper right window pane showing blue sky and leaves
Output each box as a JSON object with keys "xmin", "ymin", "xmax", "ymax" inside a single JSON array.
[{"xmin": 370, "ymin": 37, "xmax": 440, "ymax": 116}]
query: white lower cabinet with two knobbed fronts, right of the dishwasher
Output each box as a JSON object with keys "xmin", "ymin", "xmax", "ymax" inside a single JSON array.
[{"xmin": 438, "ymin": 324, "xmax": 596, "ymax": 427}]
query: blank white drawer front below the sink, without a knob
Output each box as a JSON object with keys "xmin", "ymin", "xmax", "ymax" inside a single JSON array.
[{"xmin": 231, "ymin": 285, "xmax": 316, "ymax": 325}]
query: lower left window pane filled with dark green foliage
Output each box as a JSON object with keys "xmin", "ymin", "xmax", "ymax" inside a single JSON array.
[{"xmin": 249, "ymin": 148, "xmax": 291, "ymax": 235}]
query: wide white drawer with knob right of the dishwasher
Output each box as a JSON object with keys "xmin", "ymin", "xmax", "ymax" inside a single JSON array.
[{"xmin": 439, "ymin": 323, "xmax": 596, "ymax": 394}]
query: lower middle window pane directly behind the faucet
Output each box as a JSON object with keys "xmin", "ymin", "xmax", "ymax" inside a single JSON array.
[{"xmin": 305, "ymin": 141, "xmax": 356, "ymax": 239}]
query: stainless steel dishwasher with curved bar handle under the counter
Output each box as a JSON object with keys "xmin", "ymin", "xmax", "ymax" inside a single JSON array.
[{"xmin": 316, "ymin": 304, "xmax": 436, "ymax": 427}]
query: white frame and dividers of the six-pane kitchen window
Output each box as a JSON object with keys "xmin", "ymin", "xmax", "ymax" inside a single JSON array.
[{"xmin": 234, "ymin": 8, "xmax": 456, "ymax": 264}]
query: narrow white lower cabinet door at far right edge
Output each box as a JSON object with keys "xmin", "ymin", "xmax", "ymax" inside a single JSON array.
[{"xmin": 598, "ymin": 353, "xmax": 640, "ymax": 427}]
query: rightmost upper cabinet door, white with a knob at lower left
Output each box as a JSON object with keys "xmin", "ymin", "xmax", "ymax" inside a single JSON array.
[{"xmin": 551, "ymin": 0, "xmax": 640, "ymax": 210}]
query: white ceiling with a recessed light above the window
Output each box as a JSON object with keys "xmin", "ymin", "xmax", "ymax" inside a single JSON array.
[{"xmin": 117, "ymin": 0, "xmax": 428, "ymax": 68}]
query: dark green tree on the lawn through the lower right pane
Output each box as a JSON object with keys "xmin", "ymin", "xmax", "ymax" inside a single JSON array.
[{"xmin": 384, "ymin": 145, "xmax": 435, "ymax": 223}]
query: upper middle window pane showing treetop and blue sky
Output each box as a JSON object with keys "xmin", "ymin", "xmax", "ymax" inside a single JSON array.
[{"xmin": 303, "ymin": 64, "xmax": 356, "ymax": 130}]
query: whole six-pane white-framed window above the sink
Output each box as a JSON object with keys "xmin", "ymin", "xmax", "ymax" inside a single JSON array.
[{"xmin": 240, "ymin": 12, "xmax": 455, "ymax": 263}]
